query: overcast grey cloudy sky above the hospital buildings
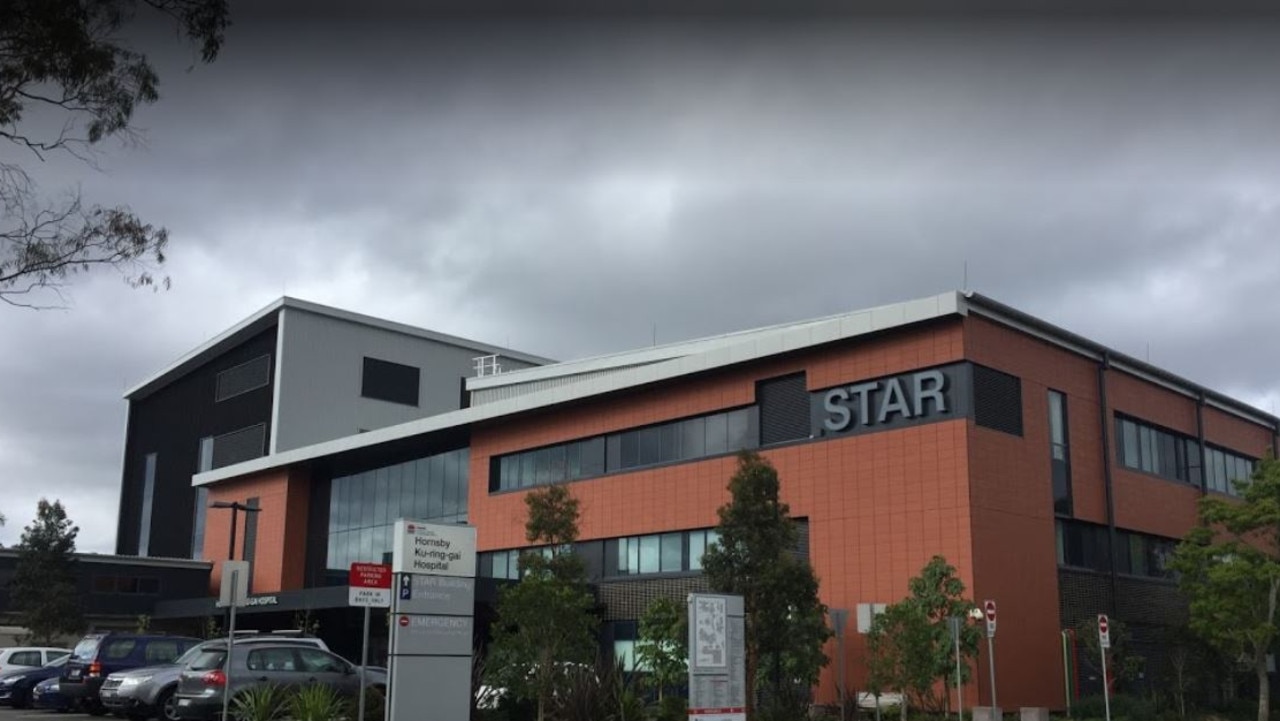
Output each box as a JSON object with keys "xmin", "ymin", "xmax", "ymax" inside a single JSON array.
[{"xmin": 0, "ymin": 5, "xmax": 1280, "ymax": 551}]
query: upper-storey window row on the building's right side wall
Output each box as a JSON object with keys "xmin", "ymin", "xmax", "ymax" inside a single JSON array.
[{"xmin": 1116, "ymin": 417, "xmax": 1253, "ymax": 494}]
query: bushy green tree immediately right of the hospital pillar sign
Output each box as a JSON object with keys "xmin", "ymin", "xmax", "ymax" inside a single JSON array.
[{"xmin": 485, "ymin": 485, "xmax": 599, "ymax": 721}]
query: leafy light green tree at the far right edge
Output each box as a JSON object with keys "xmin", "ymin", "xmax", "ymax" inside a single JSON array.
[{"xmin": 1172, "ymin": 456, "xmax": 1280, "ymax": 721}]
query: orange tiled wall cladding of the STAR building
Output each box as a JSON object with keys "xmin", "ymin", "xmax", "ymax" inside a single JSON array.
[{"xmin": 194, "ymin": 308, "xmax": 1274, "ymax": 709}]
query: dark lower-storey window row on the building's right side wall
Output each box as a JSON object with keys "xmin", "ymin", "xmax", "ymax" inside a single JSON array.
[{"xmin": 1056, "ymin": 520, "xmax": 1178, "ymax": 579}]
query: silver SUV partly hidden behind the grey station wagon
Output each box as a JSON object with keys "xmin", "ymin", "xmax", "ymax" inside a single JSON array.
[{"xmin": 99, "ymin": 631, "xmax": 329, "ymax": 721}]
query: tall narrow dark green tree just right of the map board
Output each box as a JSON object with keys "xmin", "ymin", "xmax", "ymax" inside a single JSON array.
[{"xmin": 703, "ymin": 451, "xmax": 832, "ymax": 713}]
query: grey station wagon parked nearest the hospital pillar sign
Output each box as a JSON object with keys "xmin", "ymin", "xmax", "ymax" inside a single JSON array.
[{"xmin": 175, "ymin": 642, "xmax": 387, "ymax": 721}]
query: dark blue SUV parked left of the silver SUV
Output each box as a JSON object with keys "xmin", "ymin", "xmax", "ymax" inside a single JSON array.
[{"xmin": 59, "ymin": 633, "xmax": 200, "ymax": 716}]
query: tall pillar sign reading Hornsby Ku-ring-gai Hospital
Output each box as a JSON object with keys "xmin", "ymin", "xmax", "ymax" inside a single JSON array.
[{"xmin": 387, "ymin": 519, "xmax": 476, "ymax": 721}]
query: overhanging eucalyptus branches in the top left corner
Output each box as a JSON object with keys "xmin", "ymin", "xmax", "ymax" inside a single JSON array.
[{"xmin": 0, "ymin": 0, "xmax": 228, "ymax": 307}]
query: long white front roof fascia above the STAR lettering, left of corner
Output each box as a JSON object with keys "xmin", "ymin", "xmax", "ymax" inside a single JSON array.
[{"xmin": 192, "ymin": 292, "xmax": 963, "ymax": 485}]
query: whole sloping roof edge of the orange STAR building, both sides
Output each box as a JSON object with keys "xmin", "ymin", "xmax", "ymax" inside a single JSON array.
[{"xmin": 192, "ymin": 291, "xmax": 1280, "ymax": 485}]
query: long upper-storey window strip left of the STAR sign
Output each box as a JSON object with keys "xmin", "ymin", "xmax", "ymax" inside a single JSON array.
[{"xmin": 489, "ymin": 406, "xmax": 760, "ymax": 492}]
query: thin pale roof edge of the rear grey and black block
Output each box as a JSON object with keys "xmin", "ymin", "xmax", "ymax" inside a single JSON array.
[{"xmin": 124, "ymin": 296, "xmax": 556, "ymax": 400}]
